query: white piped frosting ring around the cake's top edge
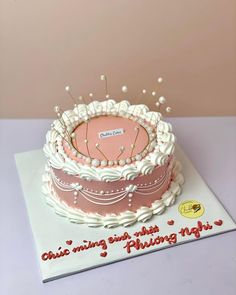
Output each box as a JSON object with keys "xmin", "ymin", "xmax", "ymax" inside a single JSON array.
[{"xmin": 44, "ymin": 99, "xmax": 175, "ymax": 182}]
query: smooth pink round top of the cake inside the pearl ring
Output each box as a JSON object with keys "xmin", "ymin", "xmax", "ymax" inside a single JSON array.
[{"xmin": 74, "ymin": 116, "xmax": 148, "ymax": 160}]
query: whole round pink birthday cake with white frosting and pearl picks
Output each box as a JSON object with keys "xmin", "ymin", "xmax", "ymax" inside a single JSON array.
[{"xmin": 43, "ymin": 77, "xmax": 184, "ymax": 228}]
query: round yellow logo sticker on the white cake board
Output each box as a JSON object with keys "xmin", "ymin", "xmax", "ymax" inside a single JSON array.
[{"xmin": 178, "ymin": 200, "xmax": 205, "ymax": 218}]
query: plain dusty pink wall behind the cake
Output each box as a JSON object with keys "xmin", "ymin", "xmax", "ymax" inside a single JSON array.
[{"xmin": 0, "ymin": 0, "xmax": 236, "ymax": 118}]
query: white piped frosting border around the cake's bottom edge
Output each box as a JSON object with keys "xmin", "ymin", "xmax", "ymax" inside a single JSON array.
[{"xmin": 43, "ymin": 162, "xmax": 184, "ymax": 228}]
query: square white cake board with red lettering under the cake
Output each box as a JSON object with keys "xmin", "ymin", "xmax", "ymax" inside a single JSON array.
[{"xmin": 15, "ymin": 147, "xmax": 236, "ymax": 282}]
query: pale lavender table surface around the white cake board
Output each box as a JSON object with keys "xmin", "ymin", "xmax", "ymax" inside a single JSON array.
[{"xmin": 0, "ymin": 117, "xmax": 236, "ymax": 295}]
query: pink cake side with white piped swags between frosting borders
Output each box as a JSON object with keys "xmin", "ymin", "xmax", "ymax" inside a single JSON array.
[{"xmin": 50, "ymin": 157, "xmax": 173, "ymax": 215}]
